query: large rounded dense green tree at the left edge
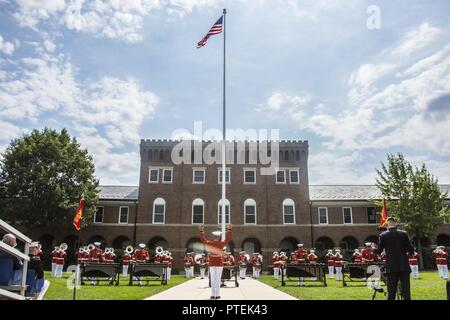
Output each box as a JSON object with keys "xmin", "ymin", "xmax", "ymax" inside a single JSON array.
[{"xmin": 0, "ymin": 128, "xmax": 98, "ymax": 231}]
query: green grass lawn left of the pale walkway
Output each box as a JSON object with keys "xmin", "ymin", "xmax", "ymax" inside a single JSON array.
[{"xmin": 44, "ymin": 272, "xmax": 187, "ymax": 300}]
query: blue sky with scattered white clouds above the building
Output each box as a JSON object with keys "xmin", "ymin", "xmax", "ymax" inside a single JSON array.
[{"xmin": 0, "ymin": 0, "xmax": 450, "ymax": 185}]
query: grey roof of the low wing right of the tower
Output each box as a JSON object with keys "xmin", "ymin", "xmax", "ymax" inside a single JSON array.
[{"xmin": 309, "ymin": 184, "xmax": 450, "ymax": 201}]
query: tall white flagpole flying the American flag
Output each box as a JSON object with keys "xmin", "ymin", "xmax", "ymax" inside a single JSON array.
[{"xmin": 221, "ymin": 8, "xmax": 227, "ymax": 240}]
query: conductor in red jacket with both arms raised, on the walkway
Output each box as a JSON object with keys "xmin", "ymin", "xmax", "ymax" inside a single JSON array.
[{"xmin": 199, "ymin": 224, "xmax": 232, "ymax": 299}]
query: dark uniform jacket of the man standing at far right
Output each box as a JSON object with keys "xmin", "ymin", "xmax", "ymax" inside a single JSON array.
[{"xmin": 375, "ymin": 228, "xmax": 414, "ymax": 273}]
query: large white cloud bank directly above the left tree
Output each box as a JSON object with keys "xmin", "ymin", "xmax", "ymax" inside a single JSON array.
[{"xmin": 0, "ymin": 48, "xmax": 158, "ymax": 184}]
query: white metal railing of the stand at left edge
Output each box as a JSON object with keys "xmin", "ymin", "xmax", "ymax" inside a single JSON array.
[{"xmin": 0, "ymin": 219, "xmax": 31, "ymax": 300}]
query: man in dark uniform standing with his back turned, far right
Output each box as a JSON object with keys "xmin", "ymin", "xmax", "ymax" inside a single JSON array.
[{"xmin": 375, "ymin": 218, "xmax": 414, "ymax": 300}]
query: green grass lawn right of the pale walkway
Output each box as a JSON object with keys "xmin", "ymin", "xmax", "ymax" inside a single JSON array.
[{"xmin": 260, "ymin": 271, "xmax": 447, "ymax": 300}]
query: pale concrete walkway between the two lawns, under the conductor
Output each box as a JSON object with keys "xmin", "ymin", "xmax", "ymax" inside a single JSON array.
[{"xmin": 145, "ymin": 278, "xmax": 297, "ymax": 300}]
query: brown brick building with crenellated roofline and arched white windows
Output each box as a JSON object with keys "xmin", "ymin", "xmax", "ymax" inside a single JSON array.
[{"xmin": 29, "ymin": 140, "xmax": 450, "ymax": 267}]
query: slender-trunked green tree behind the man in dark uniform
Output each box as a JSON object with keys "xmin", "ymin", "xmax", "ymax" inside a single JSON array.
[{"xmin": 376, "ymin": 153, "xmax": 450, "ymax": 268}]
